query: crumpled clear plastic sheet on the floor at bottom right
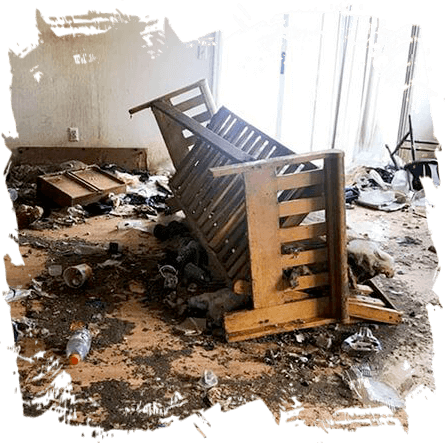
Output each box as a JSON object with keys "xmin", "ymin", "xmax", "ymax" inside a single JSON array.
[{"xmin": 345, "ymin": 365, "xmax": 403, "ymax": 411}]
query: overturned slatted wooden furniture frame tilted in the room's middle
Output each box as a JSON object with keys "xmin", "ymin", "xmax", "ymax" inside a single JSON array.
[{"xmin": 129, "ymin": 80, "xmax": 401, "ymax": 341}]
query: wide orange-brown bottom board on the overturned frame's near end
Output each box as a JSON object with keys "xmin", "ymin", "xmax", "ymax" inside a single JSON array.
[{"xmin": 224, "ymin": 297, "xmax": 330, "ymax": 333}]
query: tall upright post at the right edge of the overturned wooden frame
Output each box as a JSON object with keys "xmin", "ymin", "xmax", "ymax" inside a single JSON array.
[{"xmin": 324, "ymin": 150, "xmax": 349, "ymax": 323}]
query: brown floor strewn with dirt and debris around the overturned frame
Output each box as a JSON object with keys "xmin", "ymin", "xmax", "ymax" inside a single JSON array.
[{"xmin": 4, "ymin": 162, "xmax": 440, "ymax": 431}]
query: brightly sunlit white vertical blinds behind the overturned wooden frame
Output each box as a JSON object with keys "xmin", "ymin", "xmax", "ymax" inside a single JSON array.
[{"xmin": 220, "ymin": 11, "xmax": 432, "ymax": 166}]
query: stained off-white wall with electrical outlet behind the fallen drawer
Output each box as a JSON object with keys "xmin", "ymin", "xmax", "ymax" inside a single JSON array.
[{"xmin": 3, "ymin": 10, "xmax": 219, "ymax": 170}]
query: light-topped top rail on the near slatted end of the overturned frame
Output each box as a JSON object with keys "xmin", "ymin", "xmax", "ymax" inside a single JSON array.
[{"xmin": 210, "ymin": 149, "xmax": 343, "ymax": 177}]
